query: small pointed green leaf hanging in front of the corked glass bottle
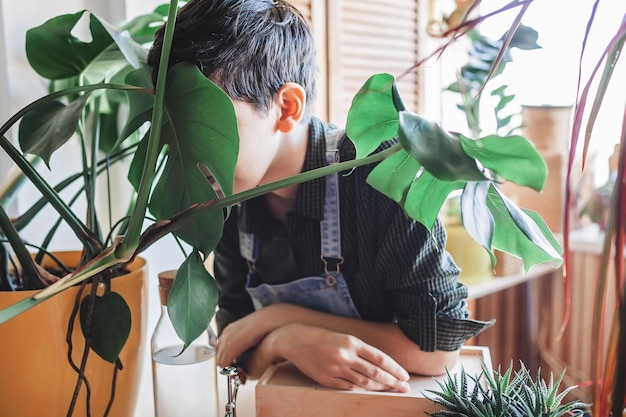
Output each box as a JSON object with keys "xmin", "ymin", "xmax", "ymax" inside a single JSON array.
[{"xmin": 167, "ymin": 250, "xmax": 217, "ymax": 347}]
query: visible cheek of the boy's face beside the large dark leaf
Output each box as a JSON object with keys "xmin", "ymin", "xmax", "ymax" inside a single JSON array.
[{"xmin": 233, "ymin": 100, "xmax": 280, "ymax": 193}]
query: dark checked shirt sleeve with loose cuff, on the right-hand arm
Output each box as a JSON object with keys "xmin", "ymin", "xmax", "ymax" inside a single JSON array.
[{"xmin": 380, "ymin": 209, "xmax": 494, "ymax": 352}]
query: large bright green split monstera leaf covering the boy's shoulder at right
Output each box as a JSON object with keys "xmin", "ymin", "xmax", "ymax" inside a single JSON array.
[{"xmin": 346, "ymin": 74, "xmax": 562, "ymax": 270}]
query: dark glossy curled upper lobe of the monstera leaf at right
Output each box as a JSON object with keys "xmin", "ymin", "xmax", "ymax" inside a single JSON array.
[{"xmin": 399, "ymin": 111, "xmax": 487, "ymax": 181}]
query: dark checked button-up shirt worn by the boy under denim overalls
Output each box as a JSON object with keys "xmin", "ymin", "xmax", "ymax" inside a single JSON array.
[{"xmin": 214, "ymin": 118, "xmax": 492, "ymax": 351}]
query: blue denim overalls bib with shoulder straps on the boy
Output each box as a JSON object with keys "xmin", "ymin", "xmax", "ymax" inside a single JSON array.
[{"xmin": 239, "ymin": 130, "xmax": 361, "ymax": 318}]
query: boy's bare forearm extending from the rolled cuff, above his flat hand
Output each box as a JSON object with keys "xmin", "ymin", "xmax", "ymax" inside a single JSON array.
[{"xmin": 255, "ymin": 304, "xmax": 458, "ymax": 375}]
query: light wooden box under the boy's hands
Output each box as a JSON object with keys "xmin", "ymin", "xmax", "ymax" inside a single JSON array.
[{"xmin": 256, "ymin": 346, "xmax": 492, "ymax": 417}]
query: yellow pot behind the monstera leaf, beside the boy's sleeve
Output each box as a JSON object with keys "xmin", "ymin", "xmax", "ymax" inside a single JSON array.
[{"xmin": 446, "ymin": 224, "xmax": 493, "ymax": 285}]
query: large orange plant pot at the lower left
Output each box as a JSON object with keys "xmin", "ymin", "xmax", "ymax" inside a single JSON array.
[{"xmin": 0, "ymin": 252, "xmax": 148, "ymax": 417}]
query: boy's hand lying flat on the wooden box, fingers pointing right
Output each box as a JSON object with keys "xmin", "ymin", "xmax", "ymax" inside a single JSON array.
[{"xmin": 263, "ymin": 324, "xmax": 410, "ymax": 392}]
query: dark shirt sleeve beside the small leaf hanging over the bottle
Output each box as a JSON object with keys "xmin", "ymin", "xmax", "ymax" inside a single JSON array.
[{"xmin": 213, "ymin": 207, "xmax": 254, "ymax": 335}]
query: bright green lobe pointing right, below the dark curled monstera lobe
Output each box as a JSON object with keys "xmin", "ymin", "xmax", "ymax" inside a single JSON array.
[{"xmin": 460, "ymin": 135, "xmax": 548, "ymax": 191}]
